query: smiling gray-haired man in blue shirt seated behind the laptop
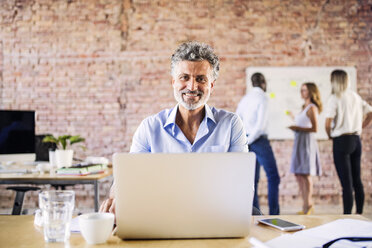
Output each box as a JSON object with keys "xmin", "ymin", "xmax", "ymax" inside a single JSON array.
[{"xmin": 100, "ymin": 41, "xmax": 248, "ymax": 212}]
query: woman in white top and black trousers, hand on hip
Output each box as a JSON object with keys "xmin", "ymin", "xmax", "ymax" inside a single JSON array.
[{"xmin": 325, "ymin": 70, "xmax": 372, "ymax": 214}]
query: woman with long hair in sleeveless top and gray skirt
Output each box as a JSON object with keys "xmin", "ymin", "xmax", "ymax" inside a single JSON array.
[{"xmin": 289, "ymin": 83, "xmax": 322, "ymax": 215}]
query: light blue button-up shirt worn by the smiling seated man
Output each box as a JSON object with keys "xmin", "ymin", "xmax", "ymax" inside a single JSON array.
[{"xmin": 130, "ymin": 105, "xmax": 248, "ymax": 153}]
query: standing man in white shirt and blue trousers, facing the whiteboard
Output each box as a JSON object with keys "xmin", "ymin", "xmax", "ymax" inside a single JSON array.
[{"xmin": 236, "ymin": 73, "xmax": 280, "ymax": 215}]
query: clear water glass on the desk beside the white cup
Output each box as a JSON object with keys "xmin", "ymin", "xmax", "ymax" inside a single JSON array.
[{"xmin": 39, "ymin": 190, "xmax": 75, "ymax": 242}]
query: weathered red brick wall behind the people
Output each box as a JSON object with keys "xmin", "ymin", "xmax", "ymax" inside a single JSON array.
[{"xmin": 0, "ymin": 0, "xmax": 372, "ymax": 213}]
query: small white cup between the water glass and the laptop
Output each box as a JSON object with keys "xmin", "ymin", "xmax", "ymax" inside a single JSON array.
[{"xmin": 79, "ymin": 213, "xmax": 115, "ymax": 245}]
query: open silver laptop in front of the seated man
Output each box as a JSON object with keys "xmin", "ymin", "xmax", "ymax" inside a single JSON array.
[{"xmin": 113, "ymin": 153, "xmax": 255, "ymax": 239}]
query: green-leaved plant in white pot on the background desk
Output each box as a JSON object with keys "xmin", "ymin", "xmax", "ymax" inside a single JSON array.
[{"xmin": 43, "ymin": 135, "xmax": 85, "ymax": 168}]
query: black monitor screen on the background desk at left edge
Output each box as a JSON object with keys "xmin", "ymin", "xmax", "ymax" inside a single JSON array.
[{"xmin": 0, "ymin": 110, "xmax": 35, "ymax": 154}]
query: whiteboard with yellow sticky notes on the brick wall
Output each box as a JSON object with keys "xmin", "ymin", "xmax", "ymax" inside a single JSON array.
[{"xmin": 246, "ymin": 66, "xmax": 357, "ymax": 140}]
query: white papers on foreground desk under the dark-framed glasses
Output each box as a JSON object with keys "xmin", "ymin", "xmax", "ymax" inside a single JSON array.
[{"xmin": 266, "ymin": 219, "xmax": 372, "ymax": 248}]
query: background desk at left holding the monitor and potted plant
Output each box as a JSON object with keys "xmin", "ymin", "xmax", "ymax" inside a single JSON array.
[{"xmin": 0, "ymin": 168, "xmax": 112, "ymax": 212}]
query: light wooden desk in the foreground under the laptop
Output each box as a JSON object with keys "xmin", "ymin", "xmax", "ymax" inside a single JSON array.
[{"xmin": 0, "ymin": 215, "xmax": 366, "ymax": 248}]
